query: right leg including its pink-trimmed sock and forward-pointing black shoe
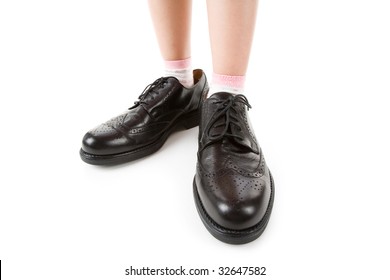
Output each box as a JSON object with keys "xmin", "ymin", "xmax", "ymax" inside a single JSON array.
[{"xmin": 194, "ymin": 0, "xmax": 274, "ymax": 244}]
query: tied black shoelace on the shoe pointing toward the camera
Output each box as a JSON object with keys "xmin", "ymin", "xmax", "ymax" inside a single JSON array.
[{"xmin": 204, "ymin": 94, "xmax": 252, "ymax": 148}]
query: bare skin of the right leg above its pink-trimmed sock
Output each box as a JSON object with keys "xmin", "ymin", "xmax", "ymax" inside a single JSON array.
[{"xmin": 207, "ymin": 0, "xmax": 258, "ymax": 76}]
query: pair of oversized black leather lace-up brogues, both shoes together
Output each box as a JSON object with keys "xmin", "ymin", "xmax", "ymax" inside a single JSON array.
[{"xmin": 80, "ymin": 70, "xmax": 274, "ymax": 244}]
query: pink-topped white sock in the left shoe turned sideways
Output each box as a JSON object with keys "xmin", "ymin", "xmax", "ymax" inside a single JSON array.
[{"xmin": 164, "ymin": 57, "xmax": 194, "ymax": 87}]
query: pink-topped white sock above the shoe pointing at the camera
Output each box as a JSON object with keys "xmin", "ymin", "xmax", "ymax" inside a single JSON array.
[{"xmin": 209, "ymin": 73, "xmax": 245, "ymax": 96}]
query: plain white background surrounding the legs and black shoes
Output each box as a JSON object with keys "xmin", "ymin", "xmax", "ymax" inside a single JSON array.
[{"xmin": 0, "ymin": 0, "xmax": 390, "ymax": 280}]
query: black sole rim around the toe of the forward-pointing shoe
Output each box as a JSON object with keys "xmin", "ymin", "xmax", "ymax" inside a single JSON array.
[{"xmin": 193, "ymin": 172, "xmax": 275, "ymax": 244}]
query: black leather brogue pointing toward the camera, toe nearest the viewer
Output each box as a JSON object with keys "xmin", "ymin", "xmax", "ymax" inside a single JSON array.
[{"xmin": 194, "ymin": 92, "xmax": 275, "ymax": 244}]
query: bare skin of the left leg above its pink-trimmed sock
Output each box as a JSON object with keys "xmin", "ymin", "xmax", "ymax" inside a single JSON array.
[{"xmin": 149, "ymin": 0, "xmax": 192, "ymax": 60}]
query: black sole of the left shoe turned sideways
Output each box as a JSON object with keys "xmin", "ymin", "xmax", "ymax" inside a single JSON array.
[{"xmin": 80, "ymin": 111, "xmax": 199, "ymax": 165}]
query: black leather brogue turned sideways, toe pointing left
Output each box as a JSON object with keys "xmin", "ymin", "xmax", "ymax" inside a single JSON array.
[{"xmin": 80, "ymin": 69, "xmax": 208, "ymax": 165}]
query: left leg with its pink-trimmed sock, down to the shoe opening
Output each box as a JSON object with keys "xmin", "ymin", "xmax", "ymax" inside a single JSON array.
[{"xmin": 149, "ymin": 0, "xmax": 193, "ymax": 86}]
